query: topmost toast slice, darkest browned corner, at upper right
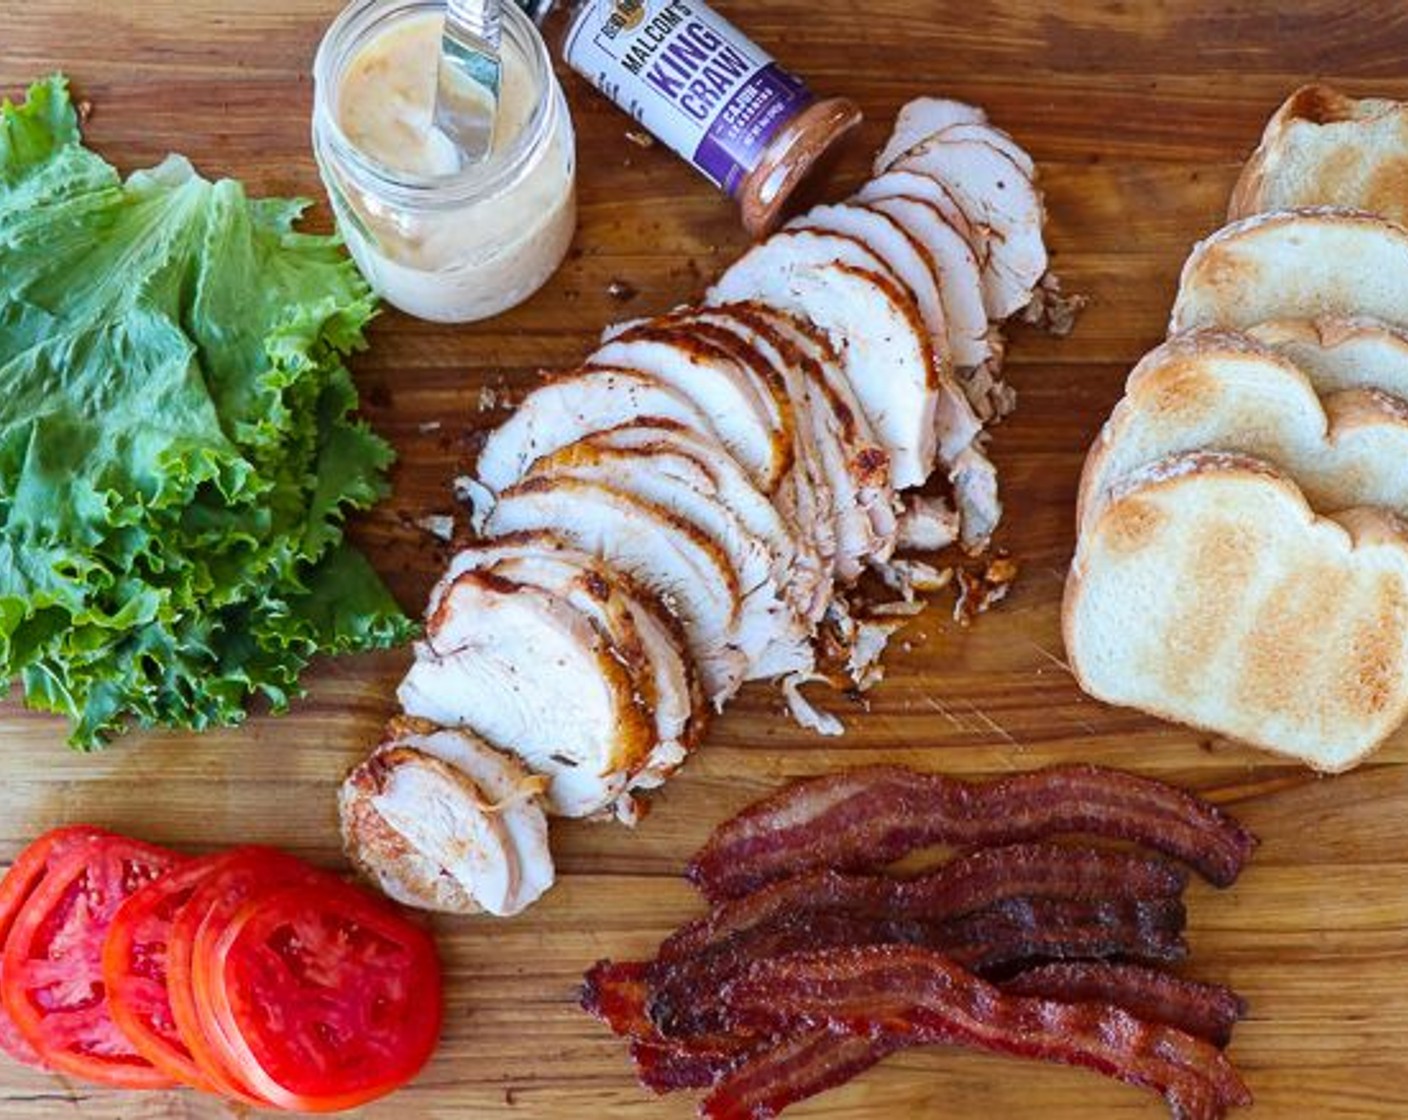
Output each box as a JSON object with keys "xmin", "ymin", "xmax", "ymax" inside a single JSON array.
[{"xmin": 1228, "ymin": 85, "xmax": 1408, "ymax": 225}]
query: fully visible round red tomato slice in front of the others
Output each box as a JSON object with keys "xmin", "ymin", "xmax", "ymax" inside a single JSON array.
[{"xmin": 201, "ymin": 882, "xmax": 442, "ymax": 1112}]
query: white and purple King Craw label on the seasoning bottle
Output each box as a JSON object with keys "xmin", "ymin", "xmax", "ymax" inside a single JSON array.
[{"xmin": 566, "ymin": 0, "xmax": 812, "ymax": 194}]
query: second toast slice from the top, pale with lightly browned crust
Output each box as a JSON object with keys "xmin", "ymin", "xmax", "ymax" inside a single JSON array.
[{"xmin": 1169, "ymin": 207, "xmax": 1408, "ymax": 334}]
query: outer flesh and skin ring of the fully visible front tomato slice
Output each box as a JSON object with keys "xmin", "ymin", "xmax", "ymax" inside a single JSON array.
[{"xmin": 199, "ymin": 881, "xmax": 444, "ymax": 1113}]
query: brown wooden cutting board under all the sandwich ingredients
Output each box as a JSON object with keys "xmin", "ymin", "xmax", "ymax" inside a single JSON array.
[{"xmin": 0, "ymin": 0, "xmax": 1408, "ymax": 1120}]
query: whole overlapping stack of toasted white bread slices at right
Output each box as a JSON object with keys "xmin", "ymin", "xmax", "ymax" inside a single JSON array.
[{"xmin": 1063, "ymin": 86, "xmax": 1408, "ymax": 772}]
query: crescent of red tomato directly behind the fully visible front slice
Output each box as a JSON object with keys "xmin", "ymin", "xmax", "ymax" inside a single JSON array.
[{"xmin": 166, "ymin": 847, "xmax": 325, "ymax": 1106}]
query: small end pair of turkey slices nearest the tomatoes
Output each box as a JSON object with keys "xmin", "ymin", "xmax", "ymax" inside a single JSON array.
[{"xmin": 339, "ymin": 718, "xmax": 553, "ymax": 916}]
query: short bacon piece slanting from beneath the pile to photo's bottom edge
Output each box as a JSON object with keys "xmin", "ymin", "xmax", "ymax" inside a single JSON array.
[{"xmin": 700, "ymin": 1030, "xmax": 910, "ymax": 1120}]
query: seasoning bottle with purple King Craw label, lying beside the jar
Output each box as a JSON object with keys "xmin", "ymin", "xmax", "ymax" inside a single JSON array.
[{"xmin": 563, "ymin": 0, "xmax": 860, "ymax": 237}]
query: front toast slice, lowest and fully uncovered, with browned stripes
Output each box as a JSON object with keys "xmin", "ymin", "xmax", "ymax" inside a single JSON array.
[{"xmin": 1063, "ymin": 452, "xmax": 1408, "ymax": 772}]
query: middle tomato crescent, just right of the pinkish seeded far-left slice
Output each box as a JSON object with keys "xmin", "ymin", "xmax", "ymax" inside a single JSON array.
[{"xmin": 103, "ymin": 855, "xmax": 230, "ymax": 1090}]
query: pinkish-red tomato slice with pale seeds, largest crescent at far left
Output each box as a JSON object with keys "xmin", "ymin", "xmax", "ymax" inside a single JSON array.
[{"xmin": 3, "ymin": 837, "xmax": 182, "ymax": 1089}]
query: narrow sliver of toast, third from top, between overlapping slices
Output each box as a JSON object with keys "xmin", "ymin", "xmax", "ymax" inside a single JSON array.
[{"xmin": 1246, "ymin": 316, "xmax": 1408, "ymax": 400}]
